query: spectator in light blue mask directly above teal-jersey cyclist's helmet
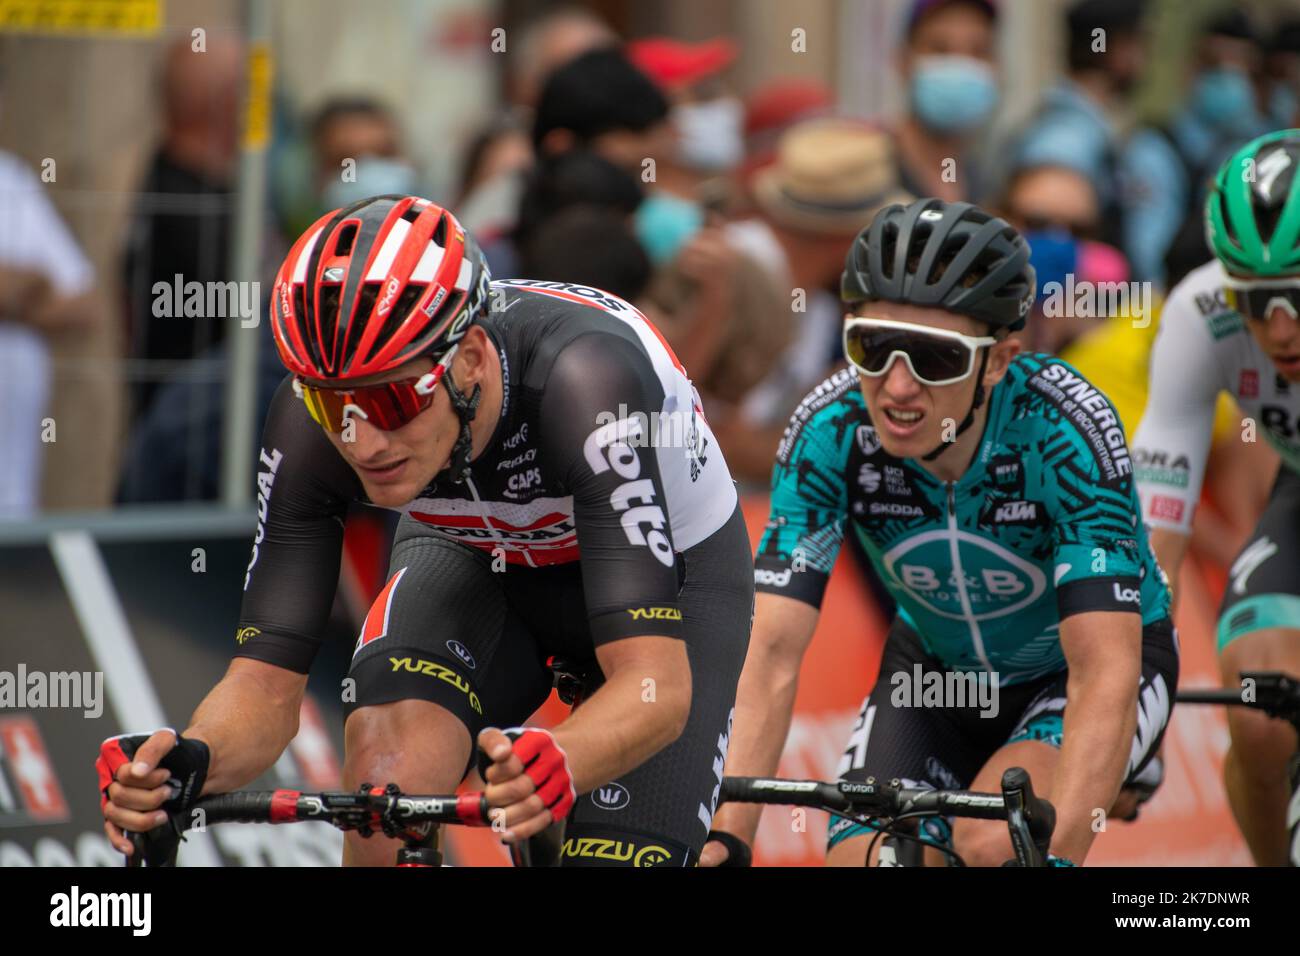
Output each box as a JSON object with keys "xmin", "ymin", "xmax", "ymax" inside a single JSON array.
[{"xmin": 894, "ymin": 0, "xmax": 998, "ymax": 202}]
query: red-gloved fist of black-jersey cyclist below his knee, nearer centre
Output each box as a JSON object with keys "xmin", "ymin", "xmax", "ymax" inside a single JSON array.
[{"xmin": 478, "ymin": 727, "xmax": 577, "ymax": 843}]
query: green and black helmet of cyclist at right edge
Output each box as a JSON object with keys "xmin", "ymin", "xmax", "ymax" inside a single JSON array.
[{"xmin": 1205, "ymin": 130, "xmax": 1300, "ymax": 278}]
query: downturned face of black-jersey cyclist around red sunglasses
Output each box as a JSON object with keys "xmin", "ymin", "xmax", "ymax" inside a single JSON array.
[{"xmin": 321, "ymin": 359, "xmax": 460, "ymax": 507}]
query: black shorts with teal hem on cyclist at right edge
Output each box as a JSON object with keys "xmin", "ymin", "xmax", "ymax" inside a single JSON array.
[{"xmin": 1216, "ymin": 464, "xmax": 1300, "ymax": 654}]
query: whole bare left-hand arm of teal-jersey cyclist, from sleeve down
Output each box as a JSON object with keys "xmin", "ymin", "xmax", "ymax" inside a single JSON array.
[{"xmin": 702, "ymin": 592, "xmax": 819, "ymax": 865}]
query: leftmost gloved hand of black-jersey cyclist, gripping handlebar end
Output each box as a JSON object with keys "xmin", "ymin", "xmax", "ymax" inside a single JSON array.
[{"xmin": 95, "ymin": 727, "xmax": 208, "ymax": 856}]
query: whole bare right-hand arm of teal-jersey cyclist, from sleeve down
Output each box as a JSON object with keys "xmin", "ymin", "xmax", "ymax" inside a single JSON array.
[{"xmin": 1050, "ymin": 611, "xmax": 1141, "ymax": 862}]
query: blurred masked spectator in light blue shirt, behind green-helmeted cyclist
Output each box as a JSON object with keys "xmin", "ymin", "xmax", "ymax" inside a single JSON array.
[{"xmin": 1122, "ymin": 10, "xmax": 1269, "ymax": 289}]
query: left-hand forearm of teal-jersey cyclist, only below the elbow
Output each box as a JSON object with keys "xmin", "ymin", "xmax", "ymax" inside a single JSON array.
[{"xmin": 714, "ymin": 645, "xmax": 800, "ymax": 843}]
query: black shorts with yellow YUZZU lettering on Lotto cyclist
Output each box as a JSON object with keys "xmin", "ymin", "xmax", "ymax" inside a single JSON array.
[{"xmin": 346, "ymin": 506, "xmax": 754, "ymax": 866}]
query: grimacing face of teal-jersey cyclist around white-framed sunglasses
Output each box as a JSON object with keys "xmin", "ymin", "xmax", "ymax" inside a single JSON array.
[{"xmin": 854, "ymin": 302, "xmax": 1008, "ymax": 458}]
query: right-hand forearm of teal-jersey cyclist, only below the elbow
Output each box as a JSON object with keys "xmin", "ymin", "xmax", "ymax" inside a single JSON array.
[{"xmin": 1052, "ymin": 667, "xmax": 1138, "ymax": 864}]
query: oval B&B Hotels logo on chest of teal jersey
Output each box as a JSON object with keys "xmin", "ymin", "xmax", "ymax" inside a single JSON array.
[{"xmin": 883, "ymin": 531, "xmax": 1047, "ymax": 620}]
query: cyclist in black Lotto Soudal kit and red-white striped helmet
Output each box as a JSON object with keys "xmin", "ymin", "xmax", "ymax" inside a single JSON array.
[{"xmin": 99, "ymin": 196, "xmax": 754, "ymax": 866}]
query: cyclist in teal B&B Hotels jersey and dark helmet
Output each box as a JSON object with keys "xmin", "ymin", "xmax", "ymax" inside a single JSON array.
[{"xmin": 703, "ymin": 199, "xmax": 1178, "ymax": 865}]
